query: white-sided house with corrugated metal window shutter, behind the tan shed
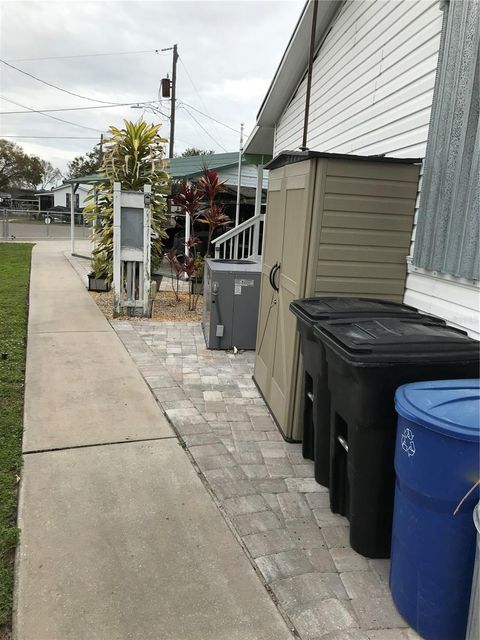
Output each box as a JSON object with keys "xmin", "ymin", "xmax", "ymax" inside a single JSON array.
[{"xmin": 245, "ymin": 0, "xmax": 480, "ymax": 337}]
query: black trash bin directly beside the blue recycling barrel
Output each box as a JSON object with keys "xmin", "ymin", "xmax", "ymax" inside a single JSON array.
[{"xmin": 314, "ymin": 317, "xmax": 479, "ymax": 558}]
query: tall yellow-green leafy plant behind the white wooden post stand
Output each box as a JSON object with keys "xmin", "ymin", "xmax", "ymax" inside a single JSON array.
[{"xmin": 85, "ymin": 120, "xmax": 170, "ymax": 280}]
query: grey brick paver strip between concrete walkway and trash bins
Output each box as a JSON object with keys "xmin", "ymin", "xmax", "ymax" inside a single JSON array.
[{"xmin": 112, "ymin": 320, "xmax": 419, "ymax": 640}]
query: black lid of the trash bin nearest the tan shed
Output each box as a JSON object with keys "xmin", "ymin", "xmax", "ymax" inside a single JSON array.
[{"xmin": 290, "ymin": 296, "xmax": 418, "ymax": 324}]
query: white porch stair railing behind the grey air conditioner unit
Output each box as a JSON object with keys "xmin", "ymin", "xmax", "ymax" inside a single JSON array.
[{"xmin": 212, "ymin": 213, "xmax": 265, "ymax": 260}]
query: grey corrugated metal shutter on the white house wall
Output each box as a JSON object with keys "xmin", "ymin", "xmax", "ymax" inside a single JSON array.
[{"xmin": 412, "ymin": 0, "xmax": 480, "ymax": 280}]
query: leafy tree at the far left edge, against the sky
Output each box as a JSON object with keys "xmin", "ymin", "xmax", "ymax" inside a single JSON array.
[{"xmin": 0, "ymin": 139, "xmax": 43, "ymax": 191}]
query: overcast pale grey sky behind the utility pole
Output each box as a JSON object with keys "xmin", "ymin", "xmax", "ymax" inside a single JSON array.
[{"xmin": 0, "ymin": 0, "xmax": 304, "ymax": 171}]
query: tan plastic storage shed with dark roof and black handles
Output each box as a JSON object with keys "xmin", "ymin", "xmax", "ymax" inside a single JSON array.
[{"xmin": 254, "ymin": 152, "xmax": 421, "ymax": 440}]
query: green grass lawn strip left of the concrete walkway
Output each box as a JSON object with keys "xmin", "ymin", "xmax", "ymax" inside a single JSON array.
[{"xmin": 0, "ymin": 243, "xmax": 33, "ymax": 637}]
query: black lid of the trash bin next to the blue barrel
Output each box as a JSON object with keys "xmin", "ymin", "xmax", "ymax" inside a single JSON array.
[{"xmin": 314, "ymin": 317, "xmax": 480, "ymax": 366}]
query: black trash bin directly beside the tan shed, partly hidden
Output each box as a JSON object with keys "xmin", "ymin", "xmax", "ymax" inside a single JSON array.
[{"xmin": 290, "ymin": 296, "xmax": 445, "ymax": 487}]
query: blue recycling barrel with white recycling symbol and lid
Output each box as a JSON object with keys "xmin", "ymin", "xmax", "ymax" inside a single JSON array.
[{"xmin": 390, "ymin": 379, "xmax": 480, "ymax": 640}]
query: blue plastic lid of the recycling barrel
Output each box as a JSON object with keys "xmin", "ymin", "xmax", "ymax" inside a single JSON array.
[{"xmin": 395, "ymin": 378, "xmax": 480, "ymax": 442}]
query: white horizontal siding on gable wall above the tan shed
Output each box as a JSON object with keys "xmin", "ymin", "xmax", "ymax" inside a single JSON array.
[{"xmin": 274, "ymin": 0, "xmax": 442, "ymax": 157}]
